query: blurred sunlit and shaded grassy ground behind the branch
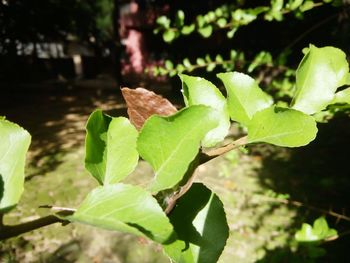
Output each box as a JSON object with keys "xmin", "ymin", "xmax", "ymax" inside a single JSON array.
[{"xmin": 0, "ymin": 82, "xmax": 350, "ymax": 263}]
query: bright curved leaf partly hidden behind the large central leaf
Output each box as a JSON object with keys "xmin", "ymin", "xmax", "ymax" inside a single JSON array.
[{"xmin": 180, "ymin": 75, "xmax": 230, "ymax": 147}]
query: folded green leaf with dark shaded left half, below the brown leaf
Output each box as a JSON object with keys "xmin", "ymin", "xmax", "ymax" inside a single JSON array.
[{"xmin": 85, "ymin": 110, "xmax": 138, "ymax": 184}]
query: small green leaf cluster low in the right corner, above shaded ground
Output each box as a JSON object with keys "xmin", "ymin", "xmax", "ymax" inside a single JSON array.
[{"xmin": 295, "ymin": 217, "xmax": 337, "ymax": 242}]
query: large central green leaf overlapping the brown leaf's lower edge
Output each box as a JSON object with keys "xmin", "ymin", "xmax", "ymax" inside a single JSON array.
[{"xmin": 137, "ymin": 105, "xmax": 218, "ymax": 192}]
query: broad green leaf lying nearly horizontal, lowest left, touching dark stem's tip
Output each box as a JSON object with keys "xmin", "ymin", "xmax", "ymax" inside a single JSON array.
[{"xmin": 67, "ymin": 184, "xmax": 173, "ymax": 243}]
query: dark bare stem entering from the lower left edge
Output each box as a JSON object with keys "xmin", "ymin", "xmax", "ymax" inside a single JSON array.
[{"xmin": 0, "ymin": 211, "xmax": 72, "ymax": 241}]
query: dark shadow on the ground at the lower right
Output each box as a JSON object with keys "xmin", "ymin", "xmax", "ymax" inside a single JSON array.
[{"xmin": 252, "ymin": 113, "xmax": 350, "ymax": 262}]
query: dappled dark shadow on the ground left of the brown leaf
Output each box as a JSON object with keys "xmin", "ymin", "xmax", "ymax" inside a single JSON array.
[{"xmin": 0, "ymin": 85, "xmax": 126, "ymax": 180}]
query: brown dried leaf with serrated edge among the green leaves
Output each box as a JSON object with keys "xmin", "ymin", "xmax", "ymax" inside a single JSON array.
[{"xmin": 121, "ymin": 88, "xmax": 177, "ymax": 130}]
